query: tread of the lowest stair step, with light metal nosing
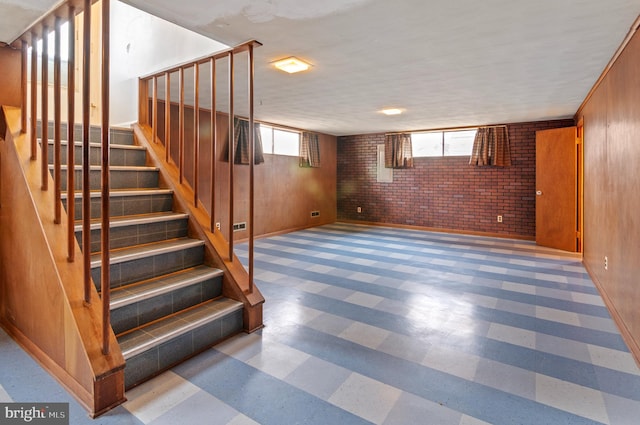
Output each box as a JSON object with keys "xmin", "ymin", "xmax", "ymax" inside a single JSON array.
[{"xmin": 118, "ymin": 298, "xmax": 243, "ymax": 359}]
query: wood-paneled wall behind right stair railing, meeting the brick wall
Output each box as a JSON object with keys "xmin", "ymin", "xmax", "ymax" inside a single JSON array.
[{"xmin": 152, "ymin": 102, "xmax": 337, "ymax": 240}]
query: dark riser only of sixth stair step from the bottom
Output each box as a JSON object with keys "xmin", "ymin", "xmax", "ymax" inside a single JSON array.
[{"xmin": 60, "ymin": 169, "xmax": 158, "ymax": 190}]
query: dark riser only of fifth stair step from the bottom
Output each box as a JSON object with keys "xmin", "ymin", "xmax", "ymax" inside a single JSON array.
[{"xmin": 62, "ymin": 194, "xmax": 173, "ymax": 220}]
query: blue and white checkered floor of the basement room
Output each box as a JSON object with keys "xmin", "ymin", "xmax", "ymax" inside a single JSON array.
[{"xmin": 0, "ymin": 224, "xmax": 640, "ymax": 425}]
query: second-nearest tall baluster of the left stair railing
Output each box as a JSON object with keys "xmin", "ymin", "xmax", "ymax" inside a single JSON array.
[{"xmin": 82, "ymin": 0, "xmax": 92, "ymax": 303}]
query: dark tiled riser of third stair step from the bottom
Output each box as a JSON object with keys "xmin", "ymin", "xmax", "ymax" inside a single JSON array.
[{"xmin": 91, "ymin": 246, "xmax": 204, "ymax": 291}]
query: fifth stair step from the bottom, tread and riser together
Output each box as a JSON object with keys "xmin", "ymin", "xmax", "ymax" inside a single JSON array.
[{"xmin": 62, "ymin": 189, "xmax": 173, "ymax": 220}]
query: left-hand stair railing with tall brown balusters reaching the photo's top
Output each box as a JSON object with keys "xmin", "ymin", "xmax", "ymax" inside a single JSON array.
[{"xmin": 13, "ymin": 0, "xmax": 111, "ymax": 355}]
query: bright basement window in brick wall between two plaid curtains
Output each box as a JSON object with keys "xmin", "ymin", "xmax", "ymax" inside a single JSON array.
[{"xmin": 411, "ymin": 128, "xmax": 476, "ymax": 158}]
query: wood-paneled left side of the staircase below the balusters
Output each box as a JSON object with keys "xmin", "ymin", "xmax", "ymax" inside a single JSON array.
[{"xmin": 0, "ymin": 106, "xmax": 125, "ymax": 415}]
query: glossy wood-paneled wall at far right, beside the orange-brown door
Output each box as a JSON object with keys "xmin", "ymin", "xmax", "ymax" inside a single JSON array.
[{"xmin": 577, "ymin": 26, "xmax": 640, "ymax": 364}]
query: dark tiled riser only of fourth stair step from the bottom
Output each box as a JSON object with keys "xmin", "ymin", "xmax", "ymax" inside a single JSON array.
[{"xmin": 76, "ymin": 219, "xmax": 188, "ymax": 252}]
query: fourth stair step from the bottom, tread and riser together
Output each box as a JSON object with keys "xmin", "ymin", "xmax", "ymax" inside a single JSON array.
[{"xmin": 74, "ymin": 212, "xmax": 189, "ymax": 252}]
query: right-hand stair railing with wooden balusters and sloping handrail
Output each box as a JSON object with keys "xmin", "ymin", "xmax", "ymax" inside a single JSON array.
[{"xmin": 138, "ymin": 40, "xmax": 261, "ymax": 293}]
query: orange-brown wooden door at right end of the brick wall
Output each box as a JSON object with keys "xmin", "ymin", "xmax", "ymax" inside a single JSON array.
[{"xmin": 536, "ymin": 127, "xmax": 578, "ymax": 252}]
